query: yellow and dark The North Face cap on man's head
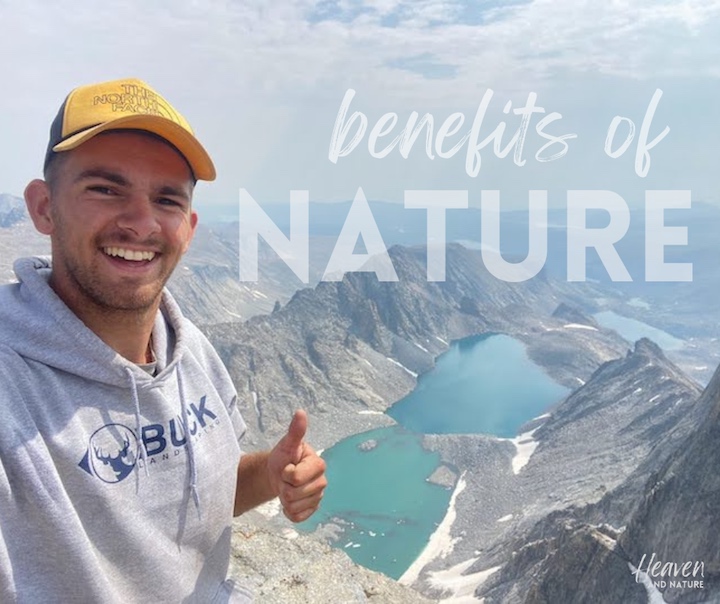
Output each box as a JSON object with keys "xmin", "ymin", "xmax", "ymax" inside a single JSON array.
[{"xmin": 45, "ymin": 78, "xmax": 215, "ymax": 180}]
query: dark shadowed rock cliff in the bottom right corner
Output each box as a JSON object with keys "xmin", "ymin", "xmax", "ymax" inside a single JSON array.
[{"xmin": 483, "ymin": 358, "xmax": 720, "ymax": 604}]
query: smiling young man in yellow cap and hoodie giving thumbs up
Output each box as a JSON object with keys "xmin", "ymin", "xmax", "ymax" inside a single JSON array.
[{"xmin": 0, "ymin": 80, "xmax": 326, "ymax": 603}]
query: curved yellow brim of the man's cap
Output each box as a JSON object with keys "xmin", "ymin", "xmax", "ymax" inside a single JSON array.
[{"xmin": 53, "ymin": 115, "xmax": 216, "ymax": 180}]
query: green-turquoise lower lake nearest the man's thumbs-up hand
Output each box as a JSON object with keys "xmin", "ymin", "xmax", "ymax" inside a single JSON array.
[{"xmin": 300, "ymin": 427, "xmax": 444, "ymax": 579}]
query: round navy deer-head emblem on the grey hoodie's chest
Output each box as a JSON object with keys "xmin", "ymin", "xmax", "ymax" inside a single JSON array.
[{"xmin": 78, "ymin": 424, "xmax": 140, "ymax": 483}]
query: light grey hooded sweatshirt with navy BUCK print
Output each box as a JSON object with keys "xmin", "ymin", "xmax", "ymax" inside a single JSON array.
[{"xmin": 0, "ymin": 258, "xmax": 250, "ymax": 603}]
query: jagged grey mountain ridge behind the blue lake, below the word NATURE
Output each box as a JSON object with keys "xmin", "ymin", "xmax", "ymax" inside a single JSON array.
[{"xmin": 207, "ymin": 246, "xmax": 626, "ymax": 447}]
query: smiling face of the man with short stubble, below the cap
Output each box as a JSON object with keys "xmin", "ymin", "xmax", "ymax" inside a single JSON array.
[{"xmin": 40, "ymin": 132, "xmax": 197, "ymax": 312}]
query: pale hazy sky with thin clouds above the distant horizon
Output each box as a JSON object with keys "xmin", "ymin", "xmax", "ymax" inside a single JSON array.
[{"xmin": 0, "ymin": 0, "xmax": 720, "ymax": 209}]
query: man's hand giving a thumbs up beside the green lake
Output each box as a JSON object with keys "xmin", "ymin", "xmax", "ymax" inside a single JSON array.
[{"xmin": 267, "ymin": 410, "xmax": 327, "ymax": 522}]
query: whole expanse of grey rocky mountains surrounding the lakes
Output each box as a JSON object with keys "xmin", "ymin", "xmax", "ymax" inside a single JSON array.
[{"xmin": 0, "ymin": 191, "xmax": 720, "ymax": 604}]
